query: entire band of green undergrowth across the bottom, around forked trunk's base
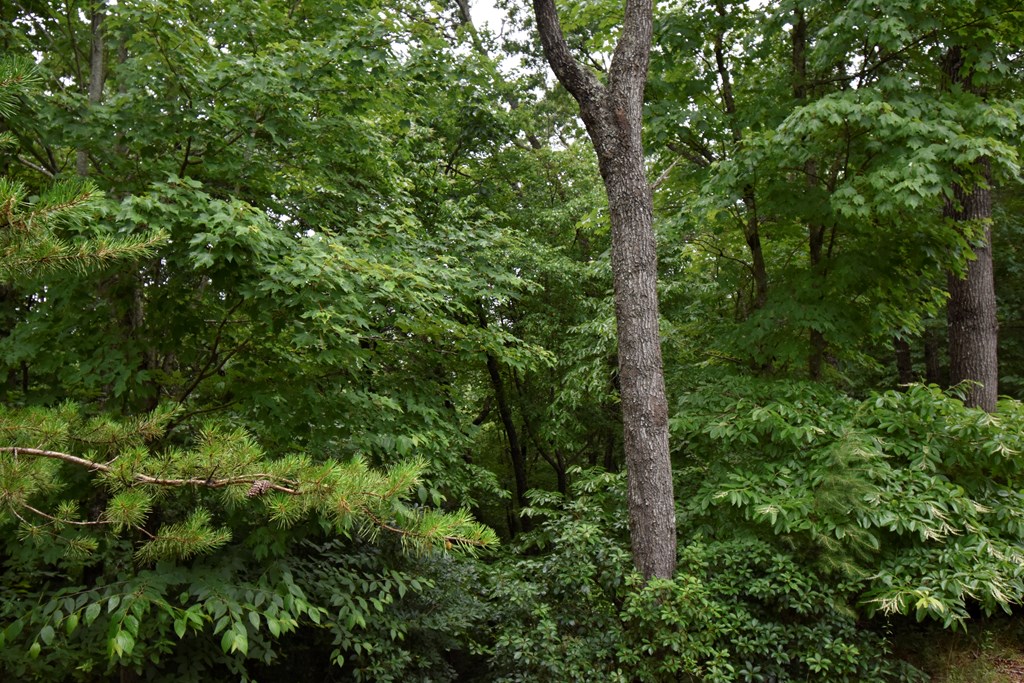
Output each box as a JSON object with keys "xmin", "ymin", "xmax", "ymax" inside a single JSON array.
[{"xmin": 0, "ymin": 376, "xmax": 1024, "ymax": 682}]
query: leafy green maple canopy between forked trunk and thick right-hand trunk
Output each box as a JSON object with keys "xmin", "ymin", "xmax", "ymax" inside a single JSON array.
[{"xmin": 648, "ymin": 0, "xmax": 1019, "ymax": 397}]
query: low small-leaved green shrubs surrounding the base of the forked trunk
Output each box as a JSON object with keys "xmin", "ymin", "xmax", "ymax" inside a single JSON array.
[{"xmin": 487, "ymin": 471, "xmax": 922, "ymax": 681}]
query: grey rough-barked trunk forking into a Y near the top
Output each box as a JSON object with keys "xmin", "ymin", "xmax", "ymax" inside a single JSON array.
[{"xmin": 534, "ymin": 0, "xmax": 676, "ymax": 579}]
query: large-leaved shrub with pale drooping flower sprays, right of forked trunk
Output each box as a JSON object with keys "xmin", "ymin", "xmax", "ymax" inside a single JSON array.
[{"xmin": 673, "ymin": 376, "xmax": 1024, "ymax": 627}]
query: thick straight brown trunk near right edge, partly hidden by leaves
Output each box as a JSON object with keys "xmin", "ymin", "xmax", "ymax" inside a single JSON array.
[{"xmin": 943, "ymin": 45, "xmax": 999, "ymax": 413}]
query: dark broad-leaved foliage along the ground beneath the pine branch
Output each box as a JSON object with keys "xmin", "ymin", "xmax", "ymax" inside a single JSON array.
[{"xmin": 0, "ymin": 530, "xmax": 487, "ymax": 681}]
